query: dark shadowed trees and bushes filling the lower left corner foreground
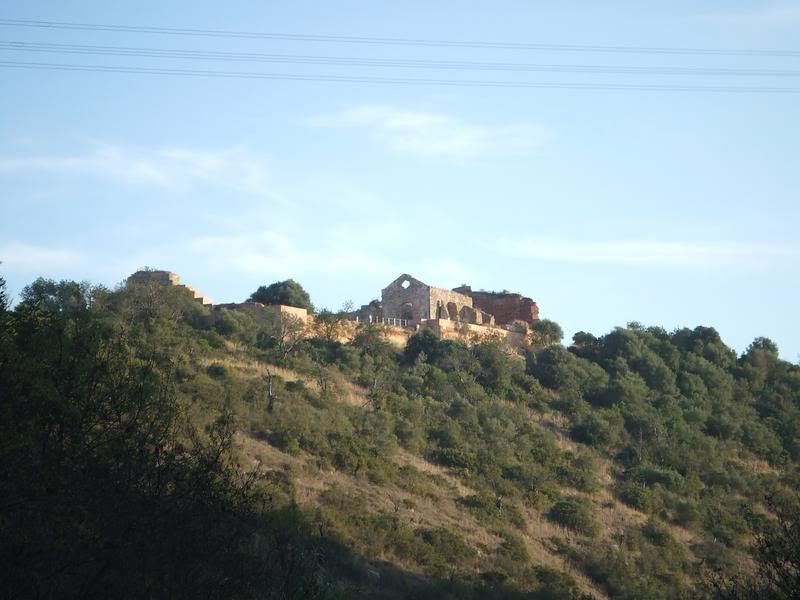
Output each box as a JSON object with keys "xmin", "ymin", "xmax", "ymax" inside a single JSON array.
[{"xmin": 0, "ymin": 280, "xmax": 338, "ymax": 598}]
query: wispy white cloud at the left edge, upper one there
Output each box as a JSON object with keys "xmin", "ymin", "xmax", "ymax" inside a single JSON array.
[{"xmin": 0, "ymin": 144, "xmax": 268, "ymax": 194}]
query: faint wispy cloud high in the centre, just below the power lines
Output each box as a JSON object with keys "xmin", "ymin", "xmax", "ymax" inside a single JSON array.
[{"xmin": 309, "ymin": 106, "xmax": 547, "ymax": 160}]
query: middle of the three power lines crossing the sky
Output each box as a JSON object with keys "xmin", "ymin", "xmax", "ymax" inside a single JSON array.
[{"xmin": 0, "ymin": 41, "xmax": 800, "ymax": 77}]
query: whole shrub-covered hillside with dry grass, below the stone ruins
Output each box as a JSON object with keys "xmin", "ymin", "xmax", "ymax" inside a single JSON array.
[{"xmin": 0, "ymin": 280, "xmax": 800, "ymax": 599}]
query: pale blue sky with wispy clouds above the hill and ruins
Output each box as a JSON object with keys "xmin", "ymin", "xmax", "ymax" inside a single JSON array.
[{"xmin": 0, "ymin": 0, "xmax": 800, "ymax": 362}]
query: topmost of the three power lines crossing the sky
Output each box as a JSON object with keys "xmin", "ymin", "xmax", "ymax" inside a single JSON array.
[{"xmin": 0, "ymin": 19, "xmax": 800, "ymax": 57}]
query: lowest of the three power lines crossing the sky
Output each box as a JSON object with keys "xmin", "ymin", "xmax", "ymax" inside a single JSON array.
[{"xmin": 0, "ymin": 61, "xmax": 800, "ymax": 94}]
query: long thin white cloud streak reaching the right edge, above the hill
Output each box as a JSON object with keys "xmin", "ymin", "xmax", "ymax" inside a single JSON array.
[{"xmin": 497, "ymin": 239, "xmax": 800, "ymax": 267}]
